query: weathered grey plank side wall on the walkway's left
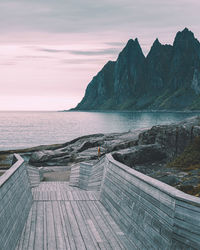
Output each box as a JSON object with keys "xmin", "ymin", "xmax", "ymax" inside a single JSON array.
[{"xmin": 0, "ymin": 155, "xmax": 33, "ymax": 250}]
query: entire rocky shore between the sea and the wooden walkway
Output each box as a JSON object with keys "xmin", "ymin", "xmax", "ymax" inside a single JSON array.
[{"xmin": 0, "ymin": 117, "xmax": 200, "ymax": 196}]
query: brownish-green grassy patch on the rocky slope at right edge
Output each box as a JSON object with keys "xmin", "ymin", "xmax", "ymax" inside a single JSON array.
[{"xmin": 167, "ymin": 136, "xmax": 200, "ymax": 171}]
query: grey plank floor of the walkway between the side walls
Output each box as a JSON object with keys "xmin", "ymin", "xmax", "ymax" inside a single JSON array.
[{"xmin": 16, "ymin": 182, "xmax": 134, "ymax": 250}]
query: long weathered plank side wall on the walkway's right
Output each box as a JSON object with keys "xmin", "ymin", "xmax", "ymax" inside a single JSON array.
[{"xmin": 100, "ymin": 155, "xmax": 200, "ymax": 250}]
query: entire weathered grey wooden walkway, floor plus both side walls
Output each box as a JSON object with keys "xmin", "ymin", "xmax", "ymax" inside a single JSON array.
[{"xmin": 0, "ymin": 152, "xmax": 200, "ymax": 250}]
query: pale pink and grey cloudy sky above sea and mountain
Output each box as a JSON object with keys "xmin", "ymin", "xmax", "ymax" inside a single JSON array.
[{"xmin": 0, "ymin": 0, "xmax": 200, "ymax": 110}]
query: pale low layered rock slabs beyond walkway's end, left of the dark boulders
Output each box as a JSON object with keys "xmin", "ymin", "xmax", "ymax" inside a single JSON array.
[{"xmin": 28, "ymin": 130, "xmax": 140, "ymax": 166}]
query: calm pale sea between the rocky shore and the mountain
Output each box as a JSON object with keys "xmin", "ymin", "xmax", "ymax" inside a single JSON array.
[{"xmin": 0, "ymin": 112, "xmax": 200, "ymax": 150}]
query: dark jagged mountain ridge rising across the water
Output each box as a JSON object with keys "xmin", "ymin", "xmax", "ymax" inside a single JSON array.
[{"xmin": 73, "ymin": 28, "xmax": 200, "ymax": 110}]
